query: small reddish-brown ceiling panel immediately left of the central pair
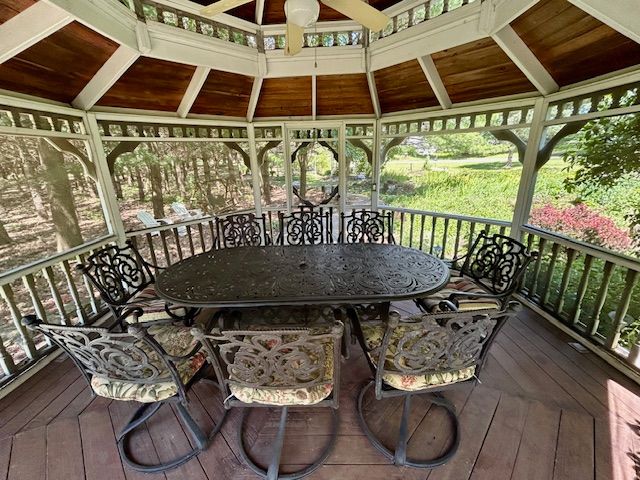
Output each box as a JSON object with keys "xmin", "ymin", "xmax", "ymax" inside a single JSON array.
[{"xmin": 191, "ymin": 70, "xmax": 253, "ymax": 117}]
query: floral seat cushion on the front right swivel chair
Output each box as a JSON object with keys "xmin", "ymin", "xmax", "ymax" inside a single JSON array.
[{"xmin": 362, "ymin": 319, "xmax": 476, "ymax": 392}]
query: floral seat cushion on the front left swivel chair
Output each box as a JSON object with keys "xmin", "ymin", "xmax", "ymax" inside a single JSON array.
[{"xmin": 91, "ymin": 324, "xmax": 206, "ymax": 403}]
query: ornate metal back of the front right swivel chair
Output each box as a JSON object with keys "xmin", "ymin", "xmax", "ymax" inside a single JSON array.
[{"xmin": 370, "ymin": 303, "xmax": 516, "ymax": 394}]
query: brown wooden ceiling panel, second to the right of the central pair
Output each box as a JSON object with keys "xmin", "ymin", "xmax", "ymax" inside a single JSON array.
[{"xmin": 432, "ymin": 38, "xmax": 536, "ymax": 103}]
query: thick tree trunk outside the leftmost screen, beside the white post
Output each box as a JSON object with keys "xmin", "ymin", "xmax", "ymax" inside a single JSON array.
[{"xmin": 38, "ymin": 139, "xmax": 83, "ymax": 252}]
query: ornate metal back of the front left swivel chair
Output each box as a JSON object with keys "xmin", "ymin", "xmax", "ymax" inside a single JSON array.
[{"xmin": 23, "ymin": 315, "xmax": 184, "ymax": 392}]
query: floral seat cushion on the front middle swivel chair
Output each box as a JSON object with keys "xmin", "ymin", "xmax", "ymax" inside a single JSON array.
[{"xmin": 229, "ymin": 340, "xmax": 334, "ymax": 406}]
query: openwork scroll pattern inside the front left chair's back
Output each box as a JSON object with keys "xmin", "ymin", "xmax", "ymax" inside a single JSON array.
[{"xmin": 38, "ymin": 325, "xmax": 171, "ymax": 383}]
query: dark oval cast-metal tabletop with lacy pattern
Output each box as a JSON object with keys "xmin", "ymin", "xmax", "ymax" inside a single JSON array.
[{"xmin": 156, "ymin": 243, "xmax": 449, "ymax": 308}]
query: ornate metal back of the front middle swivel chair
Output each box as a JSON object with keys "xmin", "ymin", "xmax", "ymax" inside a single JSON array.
[{"xmin": 192, "ymin": 322, "xmax": 344, "ymax": 405}]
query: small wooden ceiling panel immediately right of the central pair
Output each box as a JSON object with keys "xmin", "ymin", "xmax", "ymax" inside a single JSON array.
[{"xmin": 375, "ymin": 60, "xmax": 438, "ymax": 113}]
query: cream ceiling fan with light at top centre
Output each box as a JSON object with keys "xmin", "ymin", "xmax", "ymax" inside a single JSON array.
[{"xmin": 200, "ymin": 0, "xmax": 390, "ymax": 55}]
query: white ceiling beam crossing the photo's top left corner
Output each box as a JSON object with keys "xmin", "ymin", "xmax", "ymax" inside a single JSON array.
[{"xmin": 0, "ymin": 2, "xmax": 73, "ymax": 63}]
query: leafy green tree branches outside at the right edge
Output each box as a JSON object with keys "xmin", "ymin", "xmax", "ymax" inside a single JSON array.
[{"xmin": 564, "ymin": 115, "xmax": 640, "ymax": 248}]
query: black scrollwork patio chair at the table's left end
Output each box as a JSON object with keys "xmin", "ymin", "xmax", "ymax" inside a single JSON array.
[{"xmin": 76, "ymin": 240, "xmax": 200, "ymax": 324}]
